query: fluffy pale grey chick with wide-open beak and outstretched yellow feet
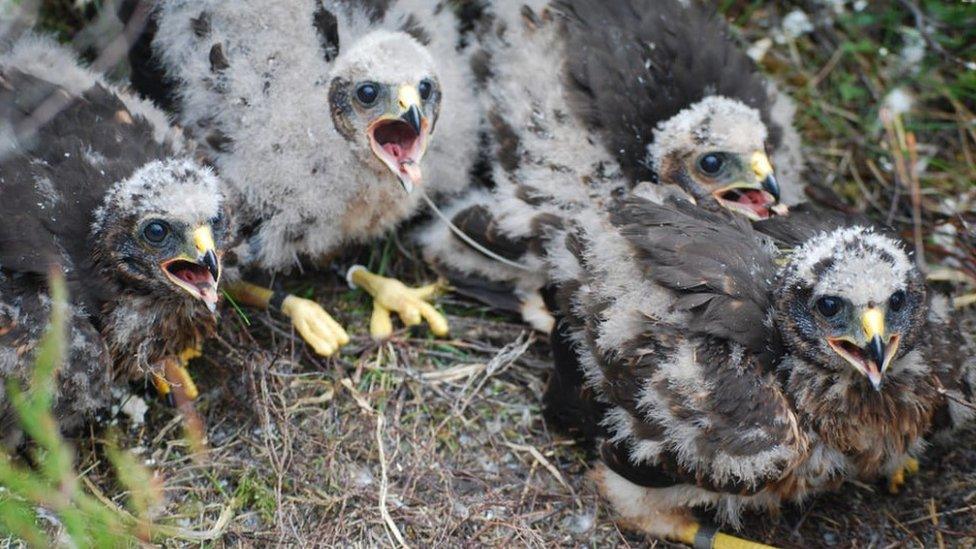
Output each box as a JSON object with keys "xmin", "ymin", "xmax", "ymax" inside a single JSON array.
[{"xmin": 132, "ymin": 0, "xmax": 479, "ymax": 348}]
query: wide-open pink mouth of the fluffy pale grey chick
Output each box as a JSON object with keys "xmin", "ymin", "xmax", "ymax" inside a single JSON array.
[{"xmin": 368, "ymin": 119, "xmax": 427, "ymax": 192}]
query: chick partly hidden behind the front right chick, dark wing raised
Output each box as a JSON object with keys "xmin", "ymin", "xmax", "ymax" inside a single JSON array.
[{"xmin": 421, "ymin": 0, "xmax": 801, "ymax": 331}]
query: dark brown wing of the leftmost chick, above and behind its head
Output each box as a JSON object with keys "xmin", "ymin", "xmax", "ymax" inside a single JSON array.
[{"xmin": 0, "ymin": 69, "xmax": 165, "ymax": 312}]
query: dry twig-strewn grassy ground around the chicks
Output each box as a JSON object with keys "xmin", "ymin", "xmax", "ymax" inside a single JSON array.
[{"xmin": 13, "ymin": 0, "xmax": 976, "ymax": 547}]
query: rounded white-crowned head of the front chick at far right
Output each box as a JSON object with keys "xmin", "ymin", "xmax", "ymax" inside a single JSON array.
[{"xmin": 776, "ymin": 227, "xmax": 927, "ymax": 391}]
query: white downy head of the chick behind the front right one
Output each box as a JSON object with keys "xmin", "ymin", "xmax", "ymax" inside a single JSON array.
[{"xmin": 648, "ymin": 95, "xmax": 780, "ymax": 220}]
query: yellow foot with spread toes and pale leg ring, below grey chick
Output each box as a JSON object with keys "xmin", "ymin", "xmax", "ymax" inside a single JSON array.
[{"xmin": 346, "ymin": 265, "xmax": 448, "ymax": 339}]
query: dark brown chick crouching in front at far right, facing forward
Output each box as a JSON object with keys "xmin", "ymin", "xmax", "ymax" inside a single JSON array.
[{"xmin": 549, "ymin": 196, "xmax": 974, "ymax": 547}]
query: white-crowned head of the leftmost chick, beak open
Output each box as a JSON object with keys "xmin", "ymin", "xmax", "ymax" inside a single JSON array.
[{"xmin": 92, "ymin": 160, "xmax": 229, "ymax": 312}]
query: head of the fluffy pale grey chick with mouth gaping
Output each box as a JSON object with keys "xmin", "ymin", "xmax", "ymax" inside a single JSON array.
[{"xmin": 329, "ymin": 31, "xmax": 441, "ymax": 193}]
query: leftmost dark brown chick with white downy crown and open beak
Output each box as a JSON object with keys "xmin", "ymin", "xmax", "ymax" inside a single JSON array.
[{"xmin": 0, "ymin": 35, "xmax": 228, "ymax": 444}]
